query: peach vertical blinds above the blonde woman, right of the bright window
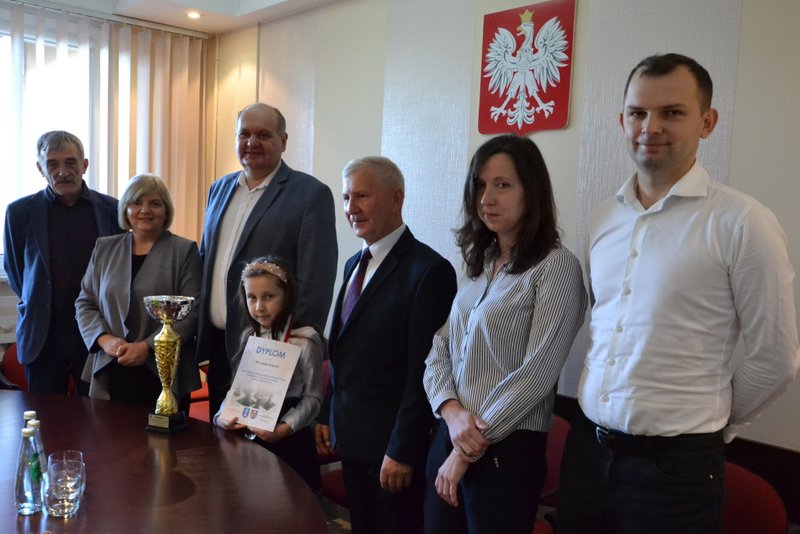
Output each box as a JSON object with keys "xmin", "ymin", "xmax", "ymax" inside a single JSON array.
[{"xmin": 117, "ymin": 26, "xmax": 205, "ymax": 240}]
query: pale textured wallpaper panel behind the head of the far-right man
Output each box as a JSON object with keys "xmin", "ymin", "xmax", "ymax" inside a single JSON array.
[{"xmin": 564, "ymin": 0, "xmax": 741, "ymax": 410}]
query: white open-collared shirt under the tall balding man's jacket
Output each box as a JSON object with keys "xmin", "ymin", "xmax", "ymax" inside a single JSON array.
[{"xmin": 208, "ymin": 162, "xmax": 283, "ymax": 330}]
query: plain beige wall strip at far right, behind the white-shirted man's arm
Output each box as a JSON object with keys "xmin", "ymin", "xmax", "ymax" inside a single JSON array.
[{"xmin": 729, "ymin": 0, "xmax": 800, "ymax": 451}]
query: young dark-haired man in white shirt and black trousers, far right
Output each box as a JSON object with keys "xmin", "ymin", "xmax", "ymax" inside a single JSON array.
[{"xmin": 559, "ymin": 54, "xmax": 800, "ymax": 534}]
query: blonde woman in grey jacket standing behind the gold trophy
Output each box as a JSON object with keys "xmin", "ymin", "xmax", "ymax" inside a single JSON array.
[{"xmin": 75, "ymin": 174, "xmax": 202, "ymax": 410}]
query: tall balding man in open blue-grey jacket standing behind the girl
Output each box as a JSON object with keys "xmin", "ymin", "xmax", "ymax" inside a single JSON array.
[{"xmin": 197, "ymin": 103, "xmax": 338, "ymax": 417}]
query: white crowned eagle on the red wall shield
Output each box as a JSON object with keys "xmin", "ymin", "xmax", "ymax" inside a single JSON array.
[{"xmin": 483, "ymin": 9, "xmax": 569, "ymax": 129}]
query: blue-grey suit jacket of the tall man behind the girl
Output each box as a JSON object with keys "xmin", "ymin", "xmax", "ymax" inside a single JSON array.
[{"xmin": 202, "ymin": 162, "xmax": 338, "ymax": 398}]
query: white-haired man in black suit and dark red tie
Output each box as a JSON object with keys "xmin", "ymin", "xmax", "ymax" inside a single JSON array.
[{"xmin": 316, "ymin": 157, "xmax": 456, "ymax": 534}]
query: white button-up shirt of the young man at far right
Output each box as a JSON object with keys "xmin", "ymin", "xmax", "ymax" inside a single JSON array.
[{"xmin": 578, "ymin": 163, "xmax": 800, "ymax": 440}]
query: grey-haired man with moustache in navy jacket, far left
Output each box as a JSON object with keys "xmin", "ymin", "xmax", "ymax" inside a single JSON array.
[{"xmin": 4, "ymin": 131, "xmax": 122, "ymax": 395}]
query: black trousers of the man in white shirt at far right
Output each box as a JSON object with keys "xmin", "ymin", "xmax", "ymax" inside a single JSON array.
[{"xmin": 558, "ymin": 417, "xmax": 725, "ymax": 534}]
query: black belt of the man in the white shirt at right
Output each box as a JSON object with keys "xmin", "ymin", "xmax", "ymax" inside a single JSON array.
[{"xmin": 582, "ymin": 416, "xmax": 724, "ymax": 452}]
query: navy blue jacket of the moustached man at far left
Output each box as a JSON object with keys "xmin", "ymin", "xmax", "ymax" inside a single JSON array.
[{"xmin": 3, "ymin": 187, "xmax": 122, "ymax": 364}]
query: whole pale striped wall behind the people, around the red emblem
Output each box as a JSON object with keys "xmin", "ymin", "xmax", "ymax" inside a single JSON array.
[{"xmin": 211, "ymin": 0, "xmax": 800, "ymax": 450}]
